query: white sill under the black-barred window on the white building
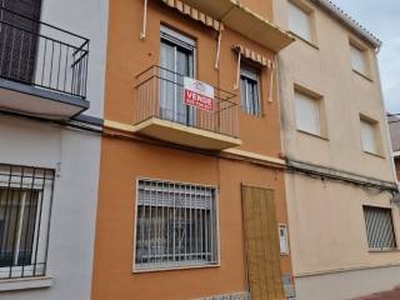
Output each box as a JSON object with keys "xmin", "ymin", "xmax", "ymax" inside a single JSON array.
[{"xmin": 0, "ymin": 276, "xmax": 53, "ymax": 292}]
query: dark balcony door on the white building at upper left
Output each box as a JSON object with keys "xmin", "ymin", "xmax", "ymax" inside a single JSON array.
[{"xmin": 0, "ymin": 0, "xmax": 42, "ymax": 83}]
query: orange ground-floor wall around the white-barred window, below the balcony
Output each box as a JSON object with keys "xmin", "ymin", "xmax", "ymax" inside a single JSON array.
[{"xmin": 92, "ymin": 139, "xmax": 291, "ymax": 300}]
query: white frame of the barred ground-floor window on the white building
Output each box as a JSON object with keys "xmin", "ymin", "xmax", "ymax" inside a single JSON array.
[{"xmin": 0, "ymin": 166, "xmax": 55, "ymax": 283}]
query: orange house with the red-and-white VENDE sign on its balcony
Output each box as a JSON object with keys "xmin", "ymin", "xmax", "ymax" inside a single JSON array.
[{"xmin": 92, "ymin": 0, "xmax": 294, "ymax": 300}]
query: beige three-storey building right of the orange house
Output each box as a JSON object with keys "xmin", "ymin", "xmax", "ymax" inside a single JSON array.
[{"xmin": 274, "ymin": 0, "xmax": 400, "ymax": 300}]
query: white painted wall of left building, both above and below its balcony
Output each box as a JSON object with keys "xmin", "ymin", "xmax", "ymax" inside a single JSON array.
[{"xmin": 0, "ymin": 0, "xmax": 108, "ymax": 300}]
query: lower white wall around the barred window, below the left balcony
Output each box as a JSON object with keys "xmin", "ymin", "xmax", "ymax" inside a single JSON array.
[{"xmin": 0, "ymin": 116, "xmax": 100, "ymax": 300}]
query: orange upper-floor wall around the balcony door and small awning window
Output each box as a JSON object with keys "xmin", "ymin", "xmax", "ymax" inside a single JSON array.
[{"xmin": 105, "ymin": 0, "xmax": 280, "ymax": 156}]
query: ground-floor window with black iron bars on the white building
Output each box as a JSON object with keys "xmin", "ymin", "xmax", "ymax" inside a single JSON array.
[{"xmin": 0, "ymin": 164, "xmax": 54, "ymax": 280}]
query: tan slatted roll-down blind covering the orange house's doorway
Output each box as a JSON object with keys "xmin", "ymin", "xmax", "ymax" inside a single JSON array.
[{"xmin": 242, "ymin": 186, "xmax": 286, "ymax": 300}]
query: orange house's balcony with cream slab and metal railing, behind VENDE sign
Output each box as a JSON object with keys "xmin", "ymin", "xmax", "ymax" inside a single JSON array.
[{"xmin": 134, "ymin": 66, "xmax": 241, "ymax": 150}]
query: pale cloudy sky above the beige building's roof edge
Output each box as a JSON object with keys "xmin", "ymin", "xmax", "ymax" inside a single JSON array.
[{"xmin": 331, "ymin": 0, "xmax": 400, "ymax": 113}]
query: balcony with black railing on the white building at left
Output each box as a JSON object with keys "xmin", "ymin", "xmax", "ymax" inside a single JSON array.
[{"xmin": 0, "ymin": 8, "xmax": 89, "ymax": 120}]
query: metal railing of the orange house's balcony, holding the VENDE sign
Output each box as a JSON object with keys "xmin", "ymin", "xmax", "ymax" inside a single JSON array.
[{"xmin": 134, "ymin": 66, "xmax": 239, "ymax": 138}]
